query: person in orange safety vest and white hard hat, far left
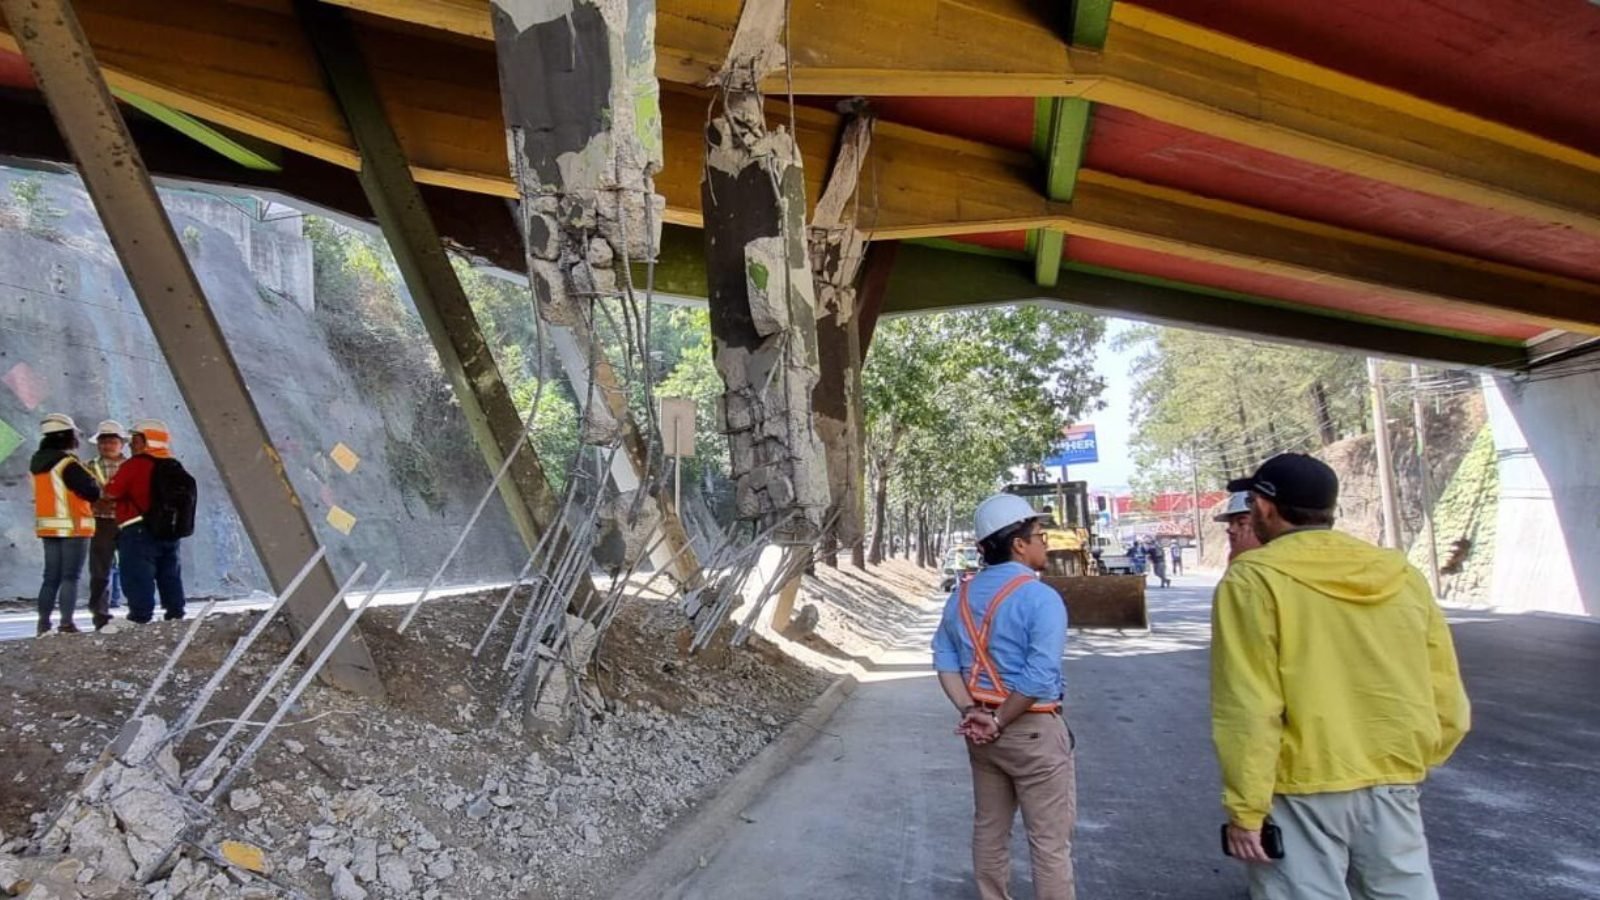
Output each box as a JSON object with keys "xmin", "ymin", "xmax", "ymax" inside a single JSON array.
[{"xmin": 27, "ymin": 413, "xmax": 101, "ymax": 634}]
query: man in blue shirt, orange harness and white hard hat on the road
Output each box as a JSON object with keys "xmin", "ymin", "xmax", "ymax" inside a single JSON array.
[{"xmin": 933, "ymin": 493, "xmax": 1077, "ymax": 900}]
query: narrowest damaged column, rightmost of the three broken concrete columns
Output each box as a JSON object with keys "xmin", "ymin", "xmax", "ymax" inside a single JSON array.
[{"xmin": 810, "ymin": 109, "xmax": 872, "ymax": 565}]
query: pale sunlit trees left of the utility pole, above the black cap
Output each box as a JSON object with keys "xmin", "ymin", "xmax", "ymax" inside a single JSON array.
[{"xmin": 1117, "ymin": 327, "xmax": 1366, "ymax": 493}]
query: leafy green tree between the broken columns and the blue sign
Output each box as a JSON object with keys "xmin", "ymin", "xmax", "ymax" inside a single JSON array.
[{"xmin": 862, "ymin": 306, "xmax": 1104, "ymax": 559}]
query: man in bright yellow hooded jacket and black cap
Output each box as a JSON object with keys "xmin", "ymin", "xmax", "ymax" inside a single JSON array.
[{"xmin": 1211, "ymin": 453, "xmax": 1470, "ymax": 900}]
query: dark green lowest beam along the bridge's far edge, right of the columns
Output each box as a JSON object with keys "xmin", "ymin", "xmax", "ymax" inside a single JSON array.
[{"xmin": 883, "ymin": 243, "xmax": 1528, "ymax": 370}]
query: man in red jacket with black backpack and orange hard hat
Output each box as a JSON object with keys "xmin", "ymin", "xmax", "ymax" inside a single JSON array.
[{"xmin": 106, "ymin": 418, "xmax": 184, "ymax": 614}]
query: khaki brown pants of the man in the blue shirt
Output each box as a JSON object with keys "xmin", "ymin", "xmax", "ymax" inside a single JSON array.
[{"xmin": 966, "ymin": 713, "xmax": 1078, "ymax": 900}]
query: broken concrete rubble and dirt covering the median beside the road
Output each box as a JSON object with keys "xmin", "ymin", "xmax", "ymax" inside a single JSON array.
[{"xmin": 0, "ymin": 594, "xmax": 826, "ymax": 900}]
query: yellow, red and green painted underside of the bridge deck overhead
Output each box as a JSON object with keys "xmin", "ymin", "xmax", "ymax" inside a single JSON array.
[{"xmin": 0, "ymin": 0, "xmax": 1600, "ymax": 368}]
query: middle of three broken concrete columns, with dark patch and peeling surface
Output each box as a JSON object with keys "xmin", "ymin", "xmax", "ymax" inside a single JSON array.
[{"xmin": 701, "ymin": 0, "xmax": 830, "ymax": 531}]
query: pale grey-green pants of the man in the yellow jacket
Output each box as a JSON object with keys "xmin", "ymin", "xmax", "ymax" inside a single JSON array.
[{"xmin": 1250, "ymin": 785, "xmax": 1438, "ymax": 900}]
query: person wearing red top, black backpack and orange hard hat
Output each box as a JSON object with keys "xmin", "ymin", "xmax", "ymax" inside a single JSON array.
[{"xmin": 106, "ymin": 420, "xmax": 195, "ymax": 623}]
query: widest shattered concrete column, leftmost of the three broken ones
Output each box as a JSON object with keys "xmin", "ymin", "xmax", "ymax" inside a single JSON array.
[{"xmin": 491, "ymin": 0, "xmax": 699, "ymax": 585}]
